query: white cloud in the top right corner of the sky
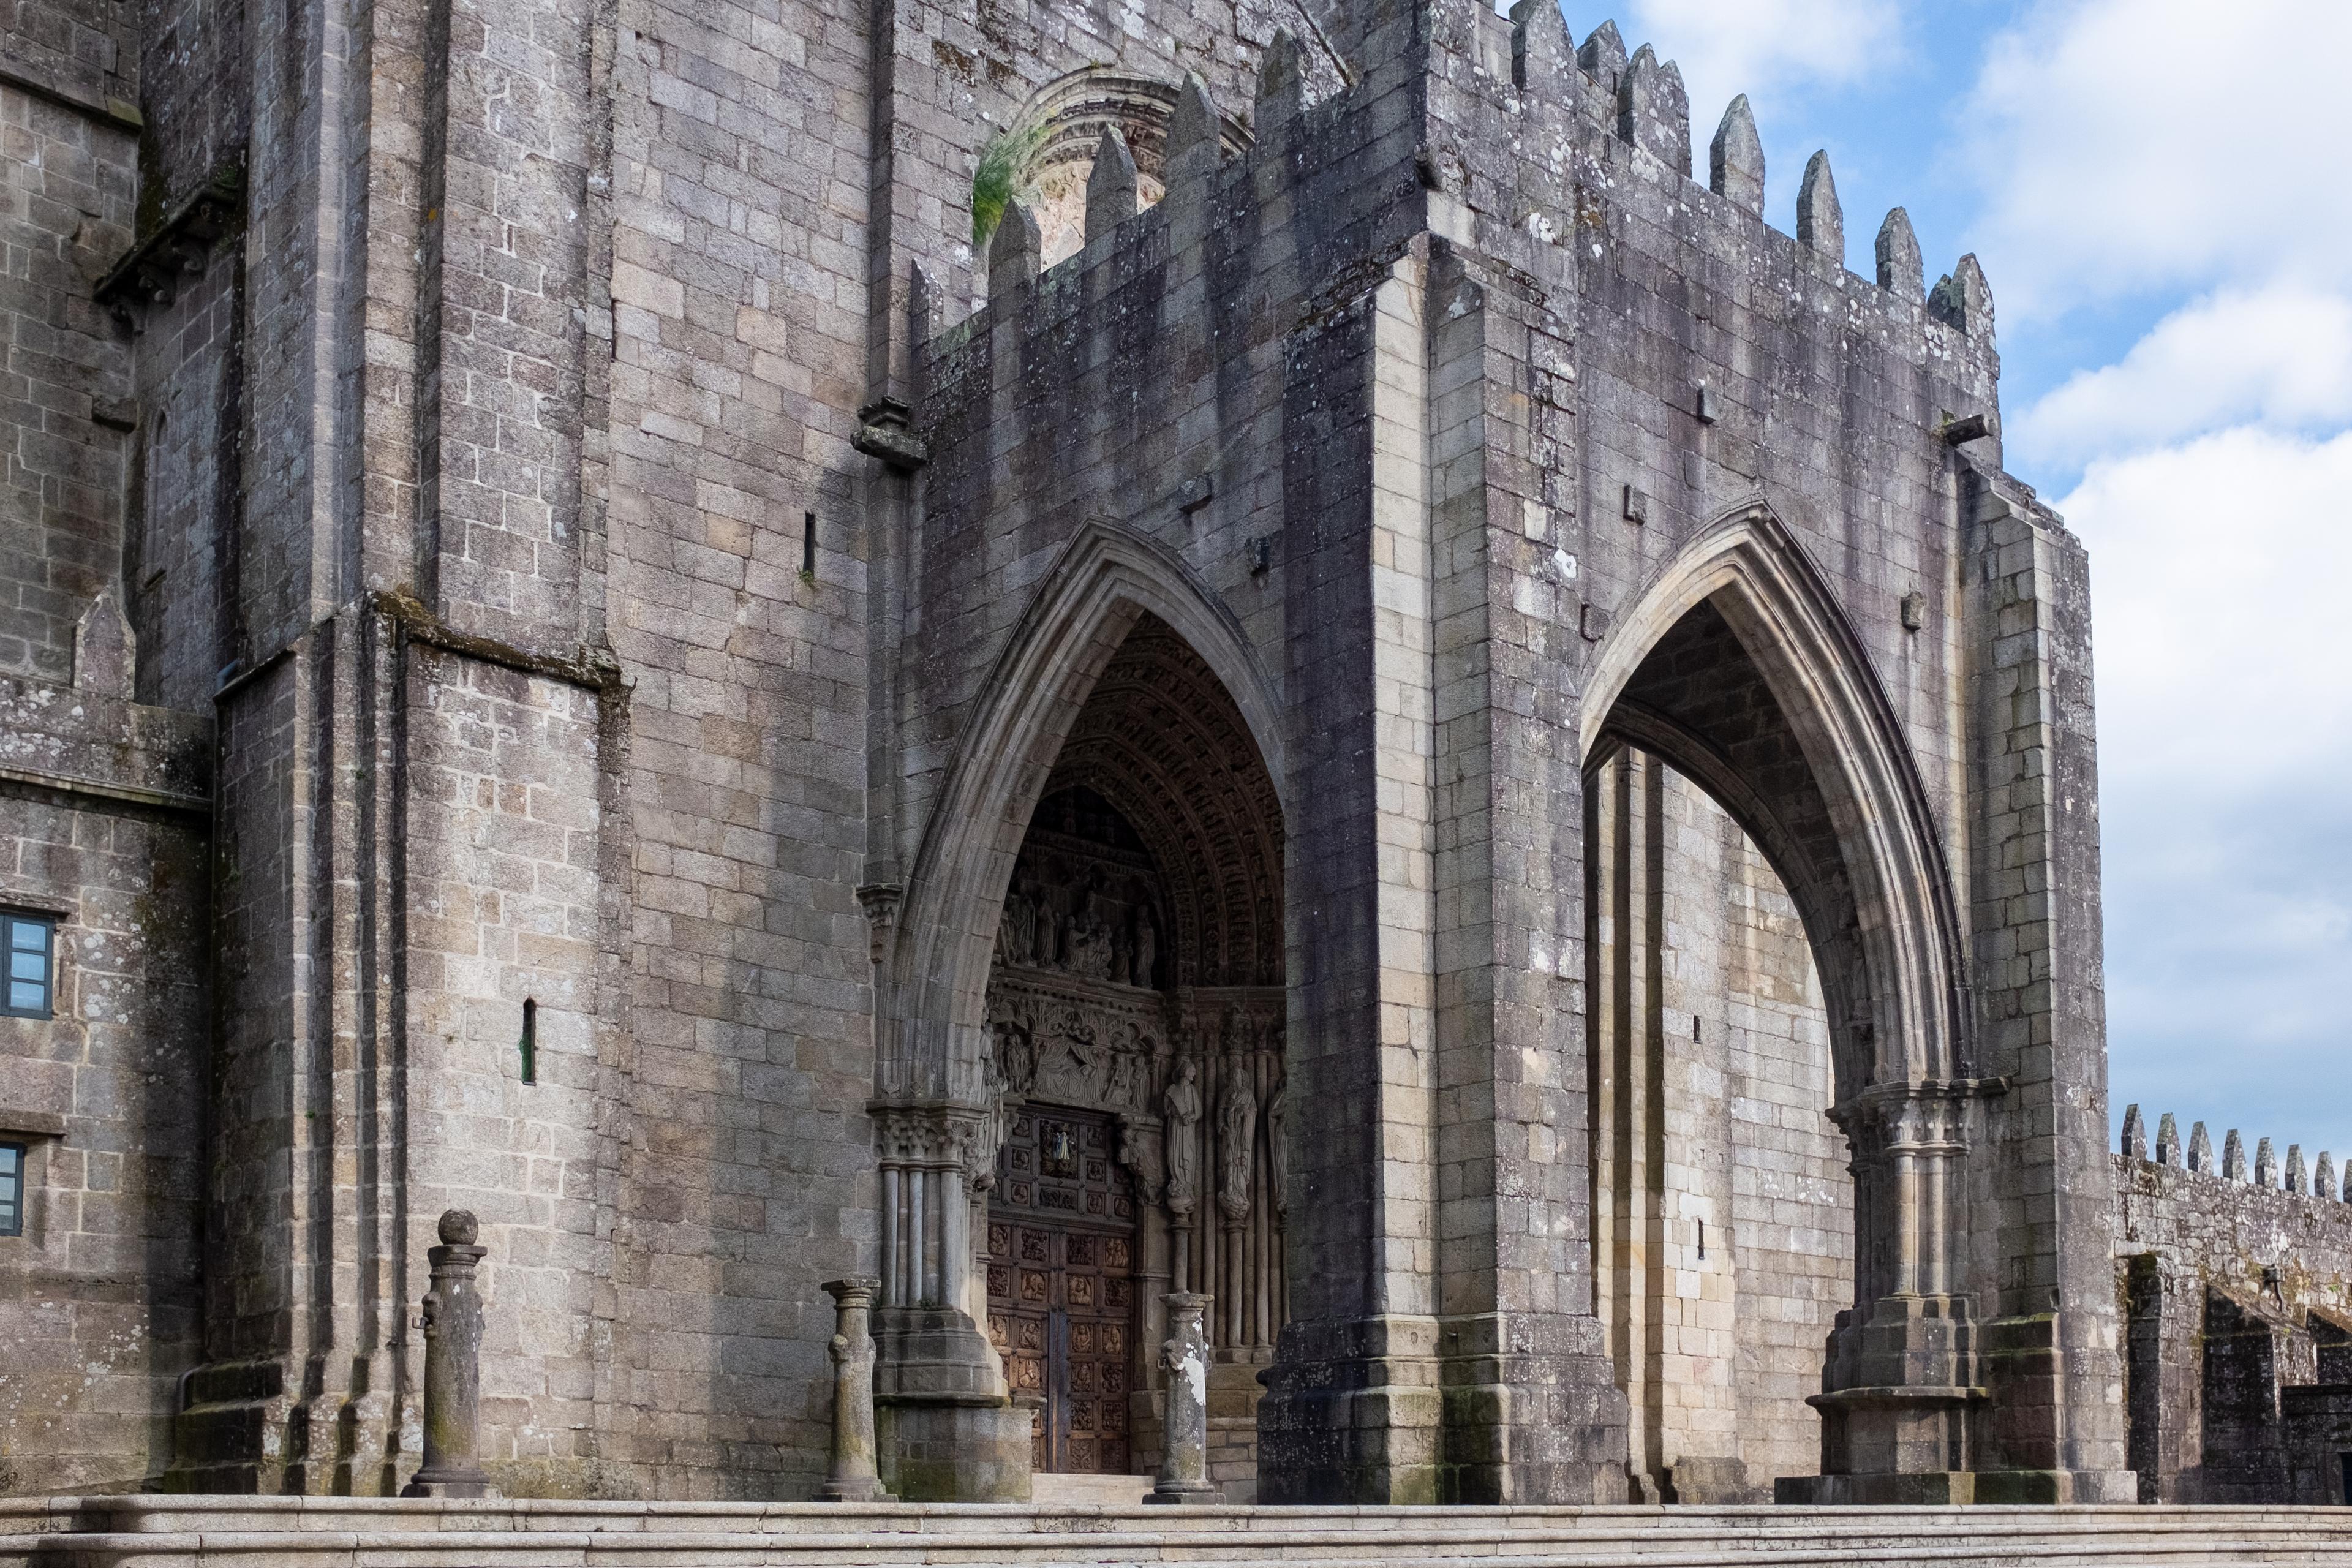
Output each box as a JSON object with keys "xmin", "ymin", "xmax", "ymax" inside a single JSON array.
[{"xmin": 1957, "ymin": 0, "xmax": 2352, "ymax": 320}]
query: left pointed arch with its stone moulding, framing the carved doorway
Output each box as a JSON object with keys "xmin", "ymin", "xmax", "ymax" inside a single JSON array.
[{"xmin": 873, "ymin": 522, "xmax": 1286, "ymax": 1495}]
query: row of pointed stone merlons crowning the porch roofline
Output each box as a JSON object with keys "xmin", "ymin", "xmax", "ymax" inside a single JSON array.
[{"xmin": 950, "ymin": 0, "xmax": 1997, "ymax": 416}]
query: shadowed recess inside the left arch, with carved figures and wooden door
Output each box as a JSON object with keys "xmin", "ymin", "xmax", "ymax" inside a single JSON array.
[{"xmin": 981, "ymin": 614, "xmax": 1286, "ymax": 1481}]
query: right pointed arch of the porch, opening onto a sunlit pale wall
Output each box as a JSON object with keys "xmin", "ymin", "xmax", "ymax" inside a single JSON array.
[{"xmin": 1583, "ymin": 505, "xmax": 1985, "ymax": 1502}]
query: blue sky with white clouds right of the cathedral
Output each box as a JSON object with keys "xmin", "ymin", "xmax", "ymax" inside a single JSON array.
[{"xmin": 1566, "ymin": 0, "xmax": 2352, "ymax": 1159}]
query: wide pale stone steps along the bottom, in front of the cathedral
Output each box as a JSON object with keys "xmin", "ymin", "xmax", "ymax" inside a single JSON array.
[{"xmin": 13, "ymin": 1498, "xmax": 2352, "ymax": 1568}]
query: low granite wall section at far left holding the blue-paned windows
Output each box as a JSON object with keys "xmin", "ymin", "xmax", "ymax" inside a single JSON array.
[{"xmin": 0, "ymin": 677, "xmax": 212, "ymax": 1493}]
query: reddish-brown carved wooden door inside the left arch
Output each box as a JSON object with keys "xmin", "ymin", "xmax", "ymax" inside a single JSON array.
[{"xmin": 988, "ymin": 1107, "xmax": 1136, "ymax": 1476}]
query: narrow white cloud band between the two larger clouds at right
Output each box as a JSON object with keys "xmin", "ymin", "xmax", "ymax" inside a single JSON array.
[{"xmin": 2008, "ymin": 284, "xmax": 2352, "ymax": 463}]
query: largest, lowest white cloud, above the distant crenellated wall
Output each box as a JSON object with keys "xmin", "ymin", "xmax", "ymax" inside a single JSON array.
[{"xmin": 2058, "ymin": 425, "xmax": 2352, "ymax": 1152}]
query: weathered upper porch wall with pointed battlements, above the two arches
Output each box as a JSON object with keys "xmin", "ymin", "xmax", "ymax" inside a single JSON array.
[{"xmin": 908, "ymin": 5, "xmax": 2041, "ymax": 940}]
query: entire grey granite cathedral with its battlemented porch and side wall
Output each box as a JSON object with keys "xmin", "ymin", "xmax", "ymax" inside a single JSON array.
[{"xmin": 0, "ymin": 0, "xmax": 2352, "ymax": 1502}]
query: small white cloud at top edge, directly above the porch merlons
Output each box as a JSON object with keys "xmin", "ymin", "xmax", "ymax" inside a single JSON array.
[{"xmin": 1627, "ymin": 0, "xmax": 1903, "ymax": 141}]
